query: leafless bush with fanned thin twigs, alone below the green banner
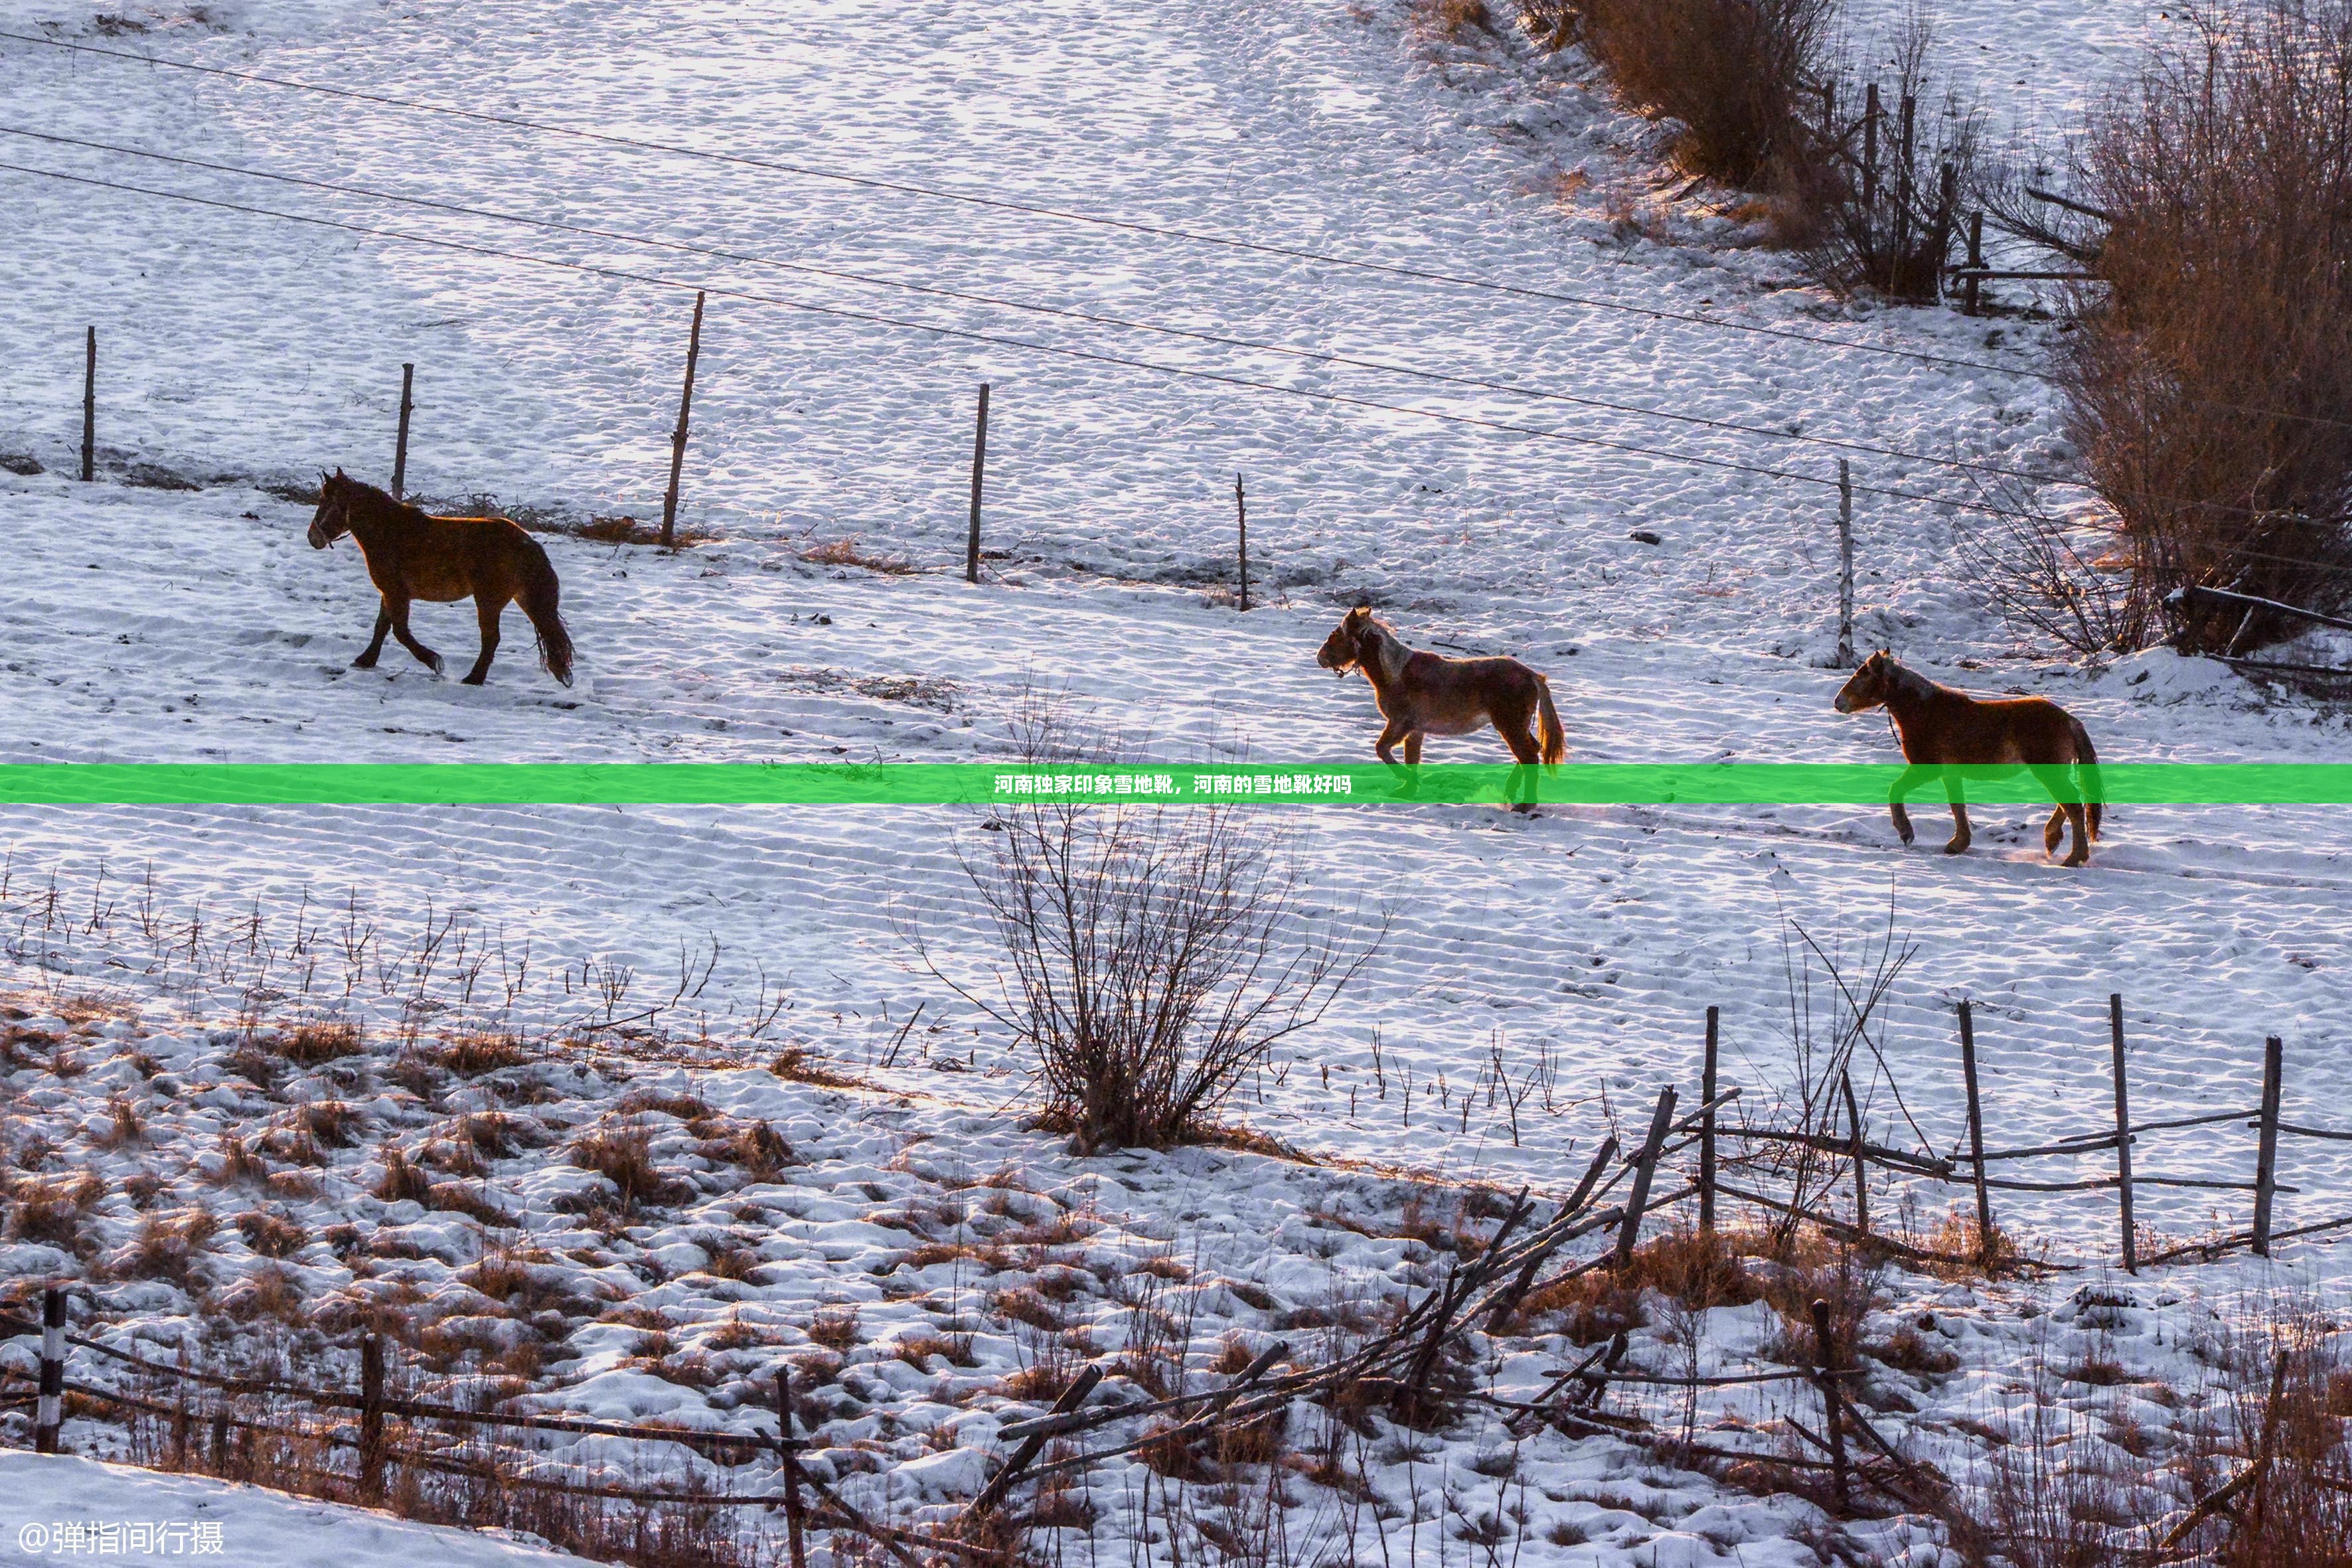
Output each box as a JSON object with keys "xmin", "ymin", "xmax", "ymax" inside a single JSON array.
[{"xmin": 908, "ymin": 698, "xmax": 1385, "ymax": 1150}]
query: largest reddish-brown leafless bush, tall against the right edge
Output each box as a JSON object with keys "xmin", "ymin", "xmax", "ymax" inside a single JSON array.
[{"xmin": 2063, "ymin": 0, "xmax": 2352, "ymax": 649}]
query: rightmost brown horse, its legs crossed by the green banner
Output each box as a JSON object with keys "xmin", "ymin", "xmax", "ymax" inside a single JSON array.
[{"xmin": 1837, "ymin": 649, "xmax": 2102, "ymax": 865}]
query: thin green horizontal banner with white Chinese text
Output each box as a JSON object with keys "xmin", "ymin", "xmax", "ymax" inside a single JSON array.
[{"xmin": 0, "ymin": 761, "xmax": 2352, "ymax": 807}]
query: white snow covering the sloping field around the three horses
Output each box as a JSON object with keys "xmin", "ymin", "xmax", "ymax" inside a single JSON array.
[{"xmin": 0, "ymin": 0, "xmax": 2352, "ymax": 1563}]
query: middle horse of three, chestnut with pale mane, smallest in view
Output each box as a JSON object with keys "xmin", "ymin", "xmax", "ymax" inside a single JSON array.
[{"xmin": 1315, "ymin": 604, "xmax": 1569, "ymax": 811}]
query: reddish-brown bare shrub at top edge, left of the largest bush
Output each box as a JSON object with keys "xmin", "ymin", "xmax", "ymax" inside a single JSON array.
[{"xmin": 1580, "ymin": 0, "xmax": 1835, "ymax": 191}]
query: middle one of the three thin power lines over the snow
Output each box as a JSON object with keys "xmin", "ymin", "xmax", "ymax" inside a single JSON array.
[{"xmin": 0, "ymin": 125, "xmax": 2079, "ymax": 496}]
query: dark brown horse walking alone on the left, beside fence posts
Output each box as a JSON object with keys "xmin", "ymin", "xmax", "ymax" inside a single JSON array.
[{"xmin": 311, "ymin": 468, "xmax": 572, "ymax": 686}]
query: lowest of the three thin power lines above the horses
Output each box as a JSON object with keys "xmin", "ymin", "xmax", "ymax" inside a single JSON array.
[{"xmin": 0, "ymin": 162, "xmax": 2027, "ymax": 517}]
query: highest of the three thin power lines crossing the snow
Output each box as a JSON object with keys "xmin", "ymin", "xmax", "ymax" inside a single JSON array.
[{"xmin": 0, "ymin": 31, "xmax": 2058, "ymax": 381}]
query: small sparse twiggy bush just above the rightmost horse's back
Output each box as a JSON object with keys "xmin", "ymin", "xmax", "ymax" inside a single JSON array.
[{"xmin": 1952, "ymin": 479, "xmax": 2159, "ymax": 661}]
